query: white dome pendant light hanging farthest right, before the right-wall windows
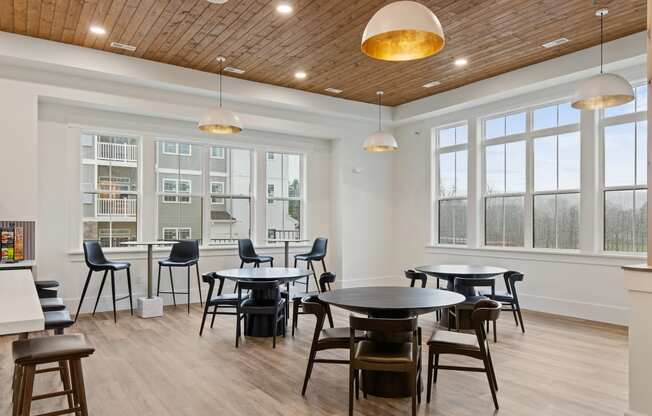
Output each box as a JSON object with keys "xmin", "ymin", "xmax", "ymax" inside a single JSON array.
[{"xmin": 571, "ymin": 9, "xmax": 634, "ymax": 110}]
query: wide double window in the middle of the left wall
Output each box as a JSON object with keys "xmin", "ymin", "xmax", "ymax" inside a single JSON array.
[{"xmin": 156, "ymin": 140, "xmax": 252, "ymax": 245}]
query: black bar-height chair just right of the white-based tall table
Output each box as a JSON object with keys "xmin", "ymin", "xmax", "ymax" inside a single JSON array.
[{"xmin": 156, "ymin": 240, "xmax": 203, "ymax": 313}]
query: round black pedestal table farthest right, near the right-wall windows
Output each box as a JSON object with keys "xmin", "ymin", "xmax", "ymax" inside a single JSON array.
[{"xmin": 415, "ymin": 264, "xmax": 508, "ymax": 329}]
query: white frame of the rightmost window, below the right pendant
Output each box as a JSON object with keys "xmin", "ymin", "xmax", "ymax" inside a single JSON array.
[{"xmin": 596, "ymin": 82, "xmax": 651, "ymax": 255}]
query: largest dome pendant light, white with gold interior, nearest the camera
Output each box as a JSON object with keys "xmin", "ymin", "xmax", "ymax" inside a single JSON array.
[{"xmin": 361, "ymin": 1, "xmax": 445, "ymax": 61}]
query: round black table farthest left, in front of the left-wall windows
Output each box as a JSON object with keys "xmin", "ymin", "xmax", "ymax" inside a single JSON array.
[{"xmin": 217, "ymin": 267, "xmax": 312, "ymax": 337}]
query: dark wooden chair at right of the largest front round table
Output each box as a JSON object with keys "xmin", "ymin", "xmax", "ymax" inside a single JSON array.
[{"xmin": 426, "ymin": 299, "xmax": 501, "ymax": 410}]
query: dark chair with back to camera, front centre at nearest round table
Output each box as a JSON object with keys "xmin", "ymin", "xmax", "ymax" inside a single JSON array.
[{"xmin": 349, "ymin": 315, "xmax": 421, "ymax": 416}]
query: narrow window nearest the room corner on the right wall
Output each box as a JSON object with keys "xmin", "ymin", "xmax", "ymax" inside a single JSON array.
[{"xmin": 434, "ymin": 123, "xmax": 468, "ymax": 244}]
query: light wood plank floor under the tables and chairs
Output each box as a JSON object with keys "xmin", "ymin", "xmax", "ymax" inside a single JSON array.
[{"xmin": 0, "ymin": 305, "xmax": 627, "ymax": 416}]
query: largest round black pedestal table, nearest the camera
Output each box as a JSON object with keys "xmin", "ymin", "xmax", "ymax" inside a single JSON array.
[{"xmin": 319, "ymin": 287, "xmax": 465, "ymax": 397}]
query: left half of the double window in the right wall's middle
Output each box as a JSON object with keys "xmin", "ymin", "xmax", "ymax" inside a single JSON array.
[{"xmin": 482, "ymin": 112, "xmax": 527, "ymax": 247}]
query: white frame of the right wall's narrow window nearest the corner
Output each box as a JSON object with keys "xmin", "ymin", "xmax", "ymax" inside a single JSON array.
[{"xmin": 431, "ymin": 121, "xmax": 471, "ymax": 247}]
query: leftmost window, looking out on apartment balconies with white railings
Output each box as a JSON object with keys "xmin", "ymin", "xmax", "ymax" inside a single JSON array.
[{"xmin": 80, "ymin": 132, "xmax": 140, "ymax": 247}]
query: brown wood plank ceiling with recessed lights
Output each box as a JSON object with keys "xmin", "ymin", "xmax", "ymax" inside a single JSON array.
[{"xmin": 0, "ymin": 0, "xmax": 646, "ymax": 105}]
